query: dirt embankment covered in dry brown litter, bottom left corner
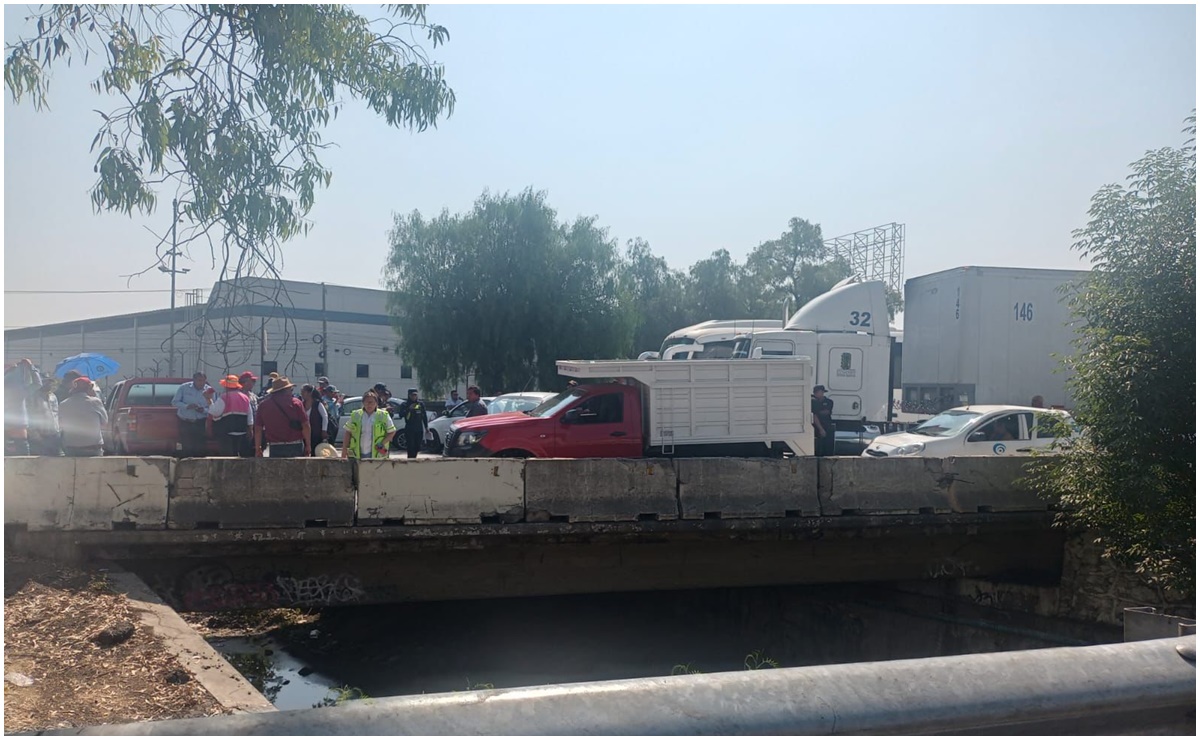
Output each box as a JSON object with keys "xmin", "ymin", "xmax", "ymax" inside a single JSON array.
[{"xmin": 4, "ymin": 555, "xmax": 223, "ymax": 733}]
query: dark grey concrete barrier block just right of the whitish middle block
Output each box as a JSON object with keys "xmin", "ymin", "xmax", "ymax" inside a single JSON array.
[{"xmin": 524, "ymin": 458, "xmax": 679, "ymax": 522}]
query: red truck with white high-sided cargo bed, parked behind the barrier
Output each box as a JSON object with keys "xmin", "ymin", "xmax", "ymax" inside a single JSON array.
[{"xmin": 445, "ymin": 357, "xmax": 812, "ymax": 457}]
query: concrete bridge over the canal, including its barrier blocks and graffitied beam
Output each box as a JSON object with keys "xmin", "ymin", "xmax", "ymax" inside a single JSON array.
[{"xmin": 5, "ymin": 457, "xmax": 1064, "ymax": 610}]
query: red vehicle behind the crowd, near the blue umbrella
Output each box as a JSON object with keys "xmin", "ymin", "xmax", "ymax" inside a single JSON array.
[{"xmin": 104, "ymin": 378, "xmax": 220, "ymax": 456}]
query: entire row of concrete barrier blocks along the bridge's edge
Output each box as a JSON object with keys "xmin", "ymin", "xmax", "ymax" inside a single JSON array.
[{"xmin": 5, "ymin": 457, "xmax": 1048, "ymax": 530}]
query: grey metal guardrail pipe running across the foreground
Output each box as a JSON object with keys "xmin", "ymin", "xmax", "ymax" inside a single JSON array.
[{"xmin": 47, "ymin": 636, "xmax": 1196, "ymax": 735}]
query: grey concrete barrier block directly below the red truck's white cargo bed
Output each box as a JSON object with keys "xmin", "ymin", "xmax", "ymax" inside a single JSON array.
[{"xmin": 674, "ymin": 457, "xmax": 821, "ymax": 519}]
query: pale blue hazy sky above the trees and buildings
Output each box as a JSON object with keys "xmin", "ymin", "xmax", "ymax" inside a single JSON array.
[{"xmin": 4, "ymin": 5, "xmax": 1196, "ymax": 326}]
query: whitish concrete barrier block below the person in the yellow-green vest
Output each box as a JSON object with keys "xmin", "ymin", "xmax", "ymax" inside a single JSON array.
[{"xmin": 356, "ymin": 458, "xmax": 526, "ymax": 524}]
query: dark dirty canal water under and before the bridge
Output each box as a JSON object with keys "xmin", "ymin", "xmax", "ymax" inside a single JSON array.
[{"xmin": 210, "ymin": 585, "xmax": 1121, "ymax": 709}]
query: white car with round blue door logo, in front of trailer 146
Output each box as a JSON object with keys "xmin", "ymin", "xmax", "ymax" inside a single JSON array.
[{"xmin": 863, "ymin": 405, "xmax": 1076, "ymax": 457}]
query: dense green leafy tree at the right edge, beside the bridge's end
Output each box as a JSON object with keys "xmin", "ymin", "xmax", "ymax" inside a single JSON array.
[{"xmin": 1030, "ymin": 114, "xmax": 1196, "ymax": 597}]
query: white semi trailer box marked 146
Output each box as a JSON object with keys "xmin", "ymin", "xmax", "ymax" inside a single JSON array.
[{"xmin": 900, "ymin": 266, "xmax": 1087, "ymax": 415}]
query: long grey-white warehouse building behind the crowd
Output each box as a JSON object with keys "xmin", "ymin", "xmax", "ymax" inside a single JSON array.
[{"xmin": 5, "ymin": 278, "xmax": 418, "ymax": 397}]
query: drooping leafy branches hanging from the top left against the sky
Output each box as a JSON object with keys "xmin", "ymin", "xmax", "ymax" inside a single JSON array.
[{"xmin": 5, "ymin": 5, "xmax": 455, "ymax": 289}]
